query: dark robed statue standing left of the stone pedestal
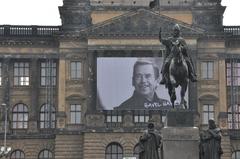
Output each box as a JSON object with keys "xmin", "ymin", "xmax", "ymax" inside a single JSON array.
[{"xmin": 137, "ymin": 122, "xmax": 162, "ymax": 159}]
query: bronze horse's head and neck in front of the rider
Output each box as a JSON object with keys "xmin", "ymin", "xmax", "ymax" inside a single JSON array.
[{"xmin": 171, "ymin": 40, "xmax": 183, "ymax": 63}]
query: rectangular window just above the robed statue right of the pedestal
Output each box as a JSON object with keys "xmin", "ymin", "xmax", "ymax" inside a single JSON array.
[{"xmin": 202, "ymin": 104, "xmax": 214, "ymax": 124}]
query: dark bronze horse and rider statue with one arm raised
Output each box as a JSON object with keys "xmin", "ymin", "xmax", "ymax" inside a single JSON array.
[{"xmin": 159, "ymin": 24, "xmax": 197, "ymax": 109}]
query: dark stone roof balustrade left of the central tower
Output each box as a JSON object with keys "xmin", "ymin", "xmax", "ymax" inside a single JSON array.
[{"xmin": 0, "ymin": 25, "xmax": 61, "ymax": 37}]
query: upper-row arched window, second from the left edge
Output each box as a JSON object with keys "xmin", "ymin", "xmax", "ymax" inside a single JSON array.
[{"xmin": 40, "ymin": 104, "xmax": 56, "ymax": 129}]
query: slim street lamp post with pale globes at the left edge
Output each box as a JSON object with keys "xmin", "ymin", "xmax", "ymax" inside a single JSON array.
[{"xmin": 0, "ymin": 103, "xmax": 12, "ymax": 158}]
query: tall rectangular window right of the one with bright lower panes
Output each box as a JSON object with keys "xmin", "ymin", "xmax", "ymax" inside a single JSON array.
[{"xmin": 40, "ymin": 61, "xmax": 57, "ymax": 86}]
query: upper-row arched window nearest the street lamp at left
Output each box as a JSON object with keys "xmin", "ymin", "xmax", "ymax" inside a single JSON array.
[{"xmin": 12, "ymin": 103, "xmax": 28, "ymax": 129}]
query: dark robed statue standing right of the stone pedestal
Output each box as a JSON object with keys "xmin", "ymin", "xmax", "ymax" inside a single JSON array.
[{"xmin": 199, "ymin": 119, "xmax": 223, "ymax": 159}]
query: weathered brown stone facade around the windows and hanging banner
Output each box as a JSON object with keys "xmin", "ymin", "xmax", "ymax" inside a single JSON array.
[{"xmin": 0, "ymin": 0, "xmax": 240, "ymax": 159}]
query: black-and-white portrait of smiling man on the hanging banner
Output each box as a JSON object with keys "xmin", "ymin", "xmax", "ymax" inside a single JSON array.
[{"xmin": 115, "ymin": 60, "xmax": 170, "ymax": 110}]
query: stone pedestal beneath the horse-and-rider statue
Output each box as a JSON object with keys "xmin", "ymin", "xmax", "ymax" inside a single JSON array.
[{"xmin": 162, "ymin": 111, "xmax": 199, "ymax": 159}]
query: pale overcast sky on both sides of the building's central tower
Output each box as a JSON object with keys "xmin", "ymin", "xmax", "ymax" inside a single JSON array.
[{"xmin": 0, "ymin": 0, "xmax": 240, "ymax": 26}]
